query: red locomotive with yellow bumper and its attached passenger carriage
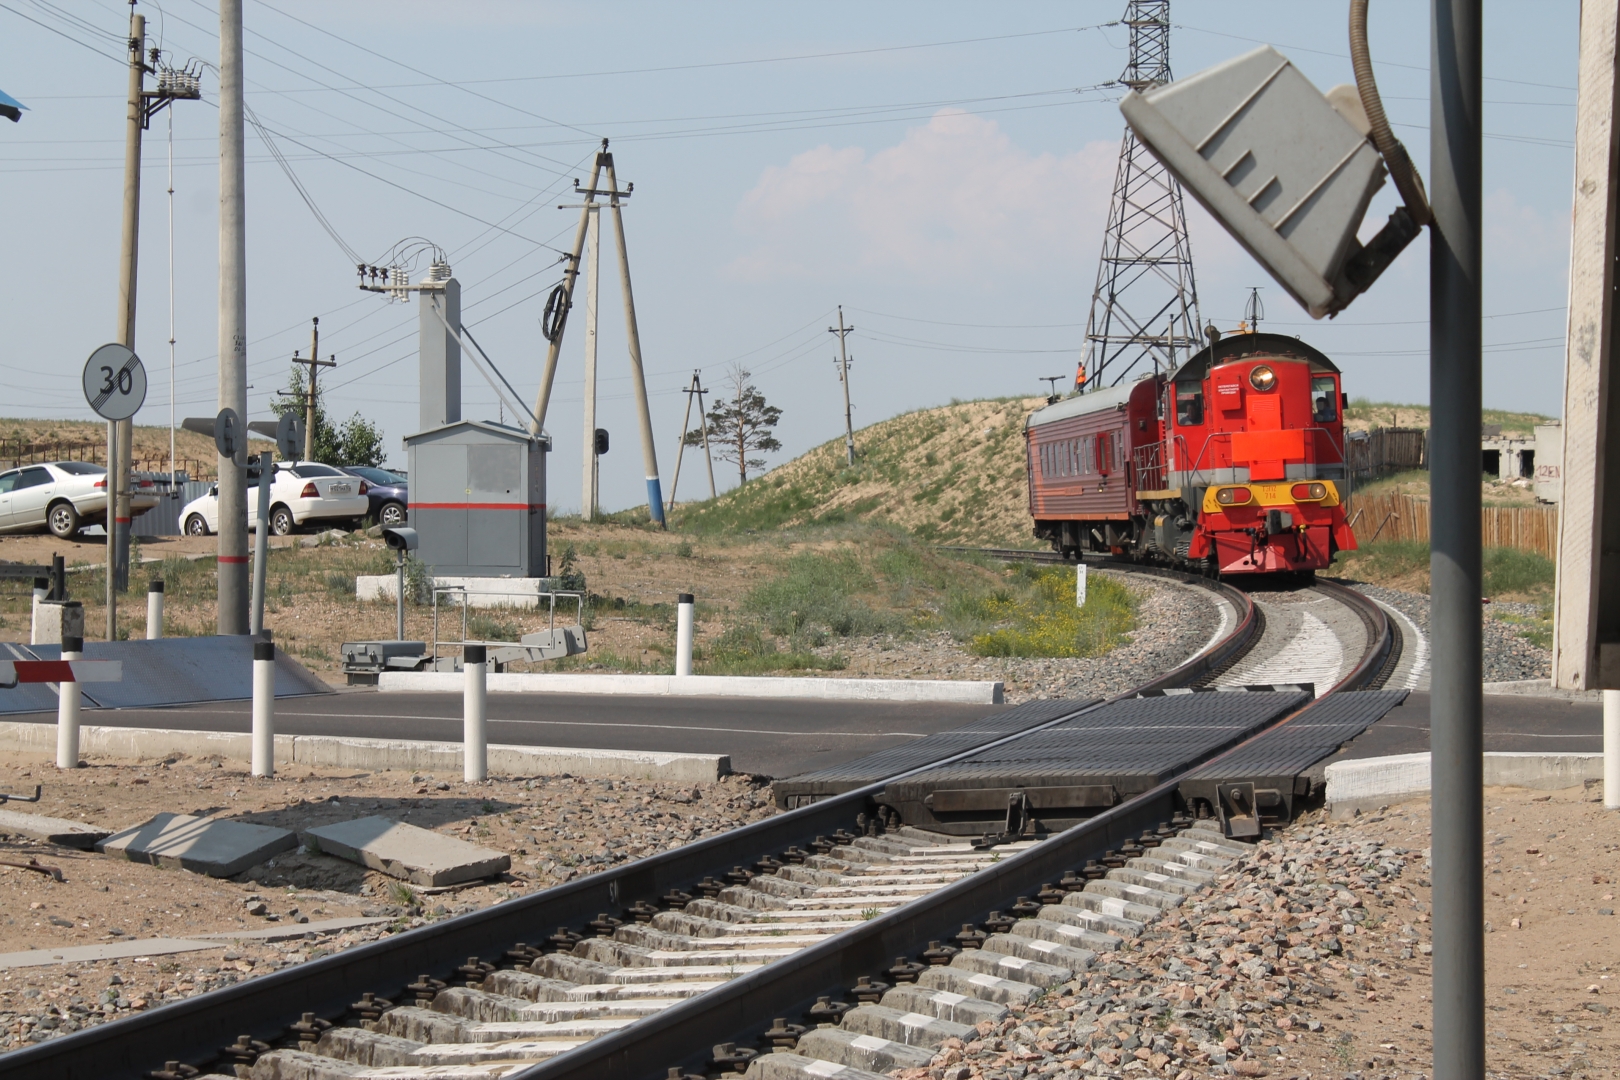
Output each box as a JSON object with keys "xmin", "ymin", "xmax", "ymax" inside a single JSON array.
[{"xmin": 1025, "ymin": 334, "xmax": 1356, "ymax": 575}]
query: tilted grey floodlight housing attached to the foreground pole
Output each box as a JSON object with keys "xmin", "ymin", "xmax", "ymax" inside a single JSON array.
[{"xmin": 1119, "ymin": 45, "xmax": 1427, "ymax": 319}]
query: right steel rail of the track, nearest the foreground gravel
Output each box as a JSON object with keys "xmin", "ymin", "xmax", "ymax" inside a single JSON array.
[{"xmin": 509, "ymin": 586, "xmax": 1393, "ymax": 1080}]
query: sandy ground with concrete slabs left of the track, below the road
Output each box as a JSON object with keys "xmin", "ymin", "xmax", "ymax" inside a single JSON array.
[{"xmin": 0, "ymin": 756, "xmax": 773, "ymax": 1048}]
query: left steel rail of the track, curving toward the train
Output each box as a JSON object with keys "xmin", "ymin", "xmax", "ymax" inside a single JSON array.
[{"xmin": 0, "ymin": 563, "xmax": 1259, "ymax": 1080}]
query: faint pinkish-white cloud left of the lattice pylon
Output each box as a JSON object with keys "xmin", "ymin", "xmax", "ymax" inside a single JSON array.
[{"xmin": 729, "ymin": 108, "xmax": 1119, "ymax": 280}]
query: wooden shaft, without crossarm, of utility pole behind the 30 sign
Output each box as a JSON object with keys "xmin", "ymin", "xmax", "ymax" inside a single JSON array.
[{"xmin": 107, "ymin": 11, "xmax": 146, "ymax": 595}]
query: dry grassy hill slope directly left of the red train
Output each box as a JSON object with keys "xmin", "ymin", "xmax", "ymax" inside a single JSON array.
[{"xmin": 672, "ymin": 397, "xmax": 1045, "ymax": 547}]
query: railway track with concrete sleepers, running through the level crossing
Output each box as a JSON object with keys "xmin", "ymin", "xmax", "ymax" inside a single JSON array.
[{"xmin": 5, "ymin": 557, "xmax": 1393, "ymax": 1080}]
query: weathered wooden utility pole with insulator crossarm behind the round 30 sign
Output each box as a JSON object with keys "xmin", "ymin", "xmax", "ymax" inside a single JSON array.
[{"xmin": 107, "ymin": 0, "xmax": 203, "ymax": 641}]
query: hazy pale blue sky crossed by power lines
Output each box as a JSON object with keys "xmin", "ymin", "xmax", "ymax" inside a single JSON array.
[{"xmin": 0, "ymin": 0, "xmax": 1578, "ymax": 508}]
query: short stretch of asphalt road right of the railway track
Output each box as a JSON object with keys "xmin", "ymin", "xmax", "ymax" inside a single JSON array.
[{"xmin": 1335, "ymin": 693, "xmax": 1604, "ymax": 761}]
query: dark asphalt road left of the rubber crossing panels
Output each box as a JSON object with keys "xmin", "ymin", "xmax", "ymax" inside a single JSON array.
[{"xmin": 5, "ymin": 690, "xmax": 1009, "ymax": 777}]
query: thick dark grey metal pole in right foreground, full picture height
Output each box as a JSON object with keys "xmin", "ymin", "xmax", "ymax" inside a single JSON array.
[{"xmin": 1429, "ymin": 0, "xmax": 1486, "ymax": 1080}]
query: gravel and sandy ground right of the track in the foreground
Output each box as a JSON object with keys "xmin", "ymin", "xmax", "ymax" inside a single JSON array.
[{"xmin": 894, "ymin": 789, "xmax": 1620, "ymax": 1080}]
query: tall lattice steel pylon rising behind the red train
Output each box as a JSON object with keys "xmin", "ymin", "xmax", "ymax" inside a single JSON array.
[{"xmin": 1076, "ymin": 0, "xmax": 1202, "ymax": 390}]
